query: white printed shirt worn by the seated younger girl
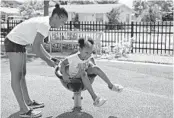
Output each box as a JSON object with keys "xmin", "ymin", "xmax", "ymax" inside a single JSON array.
[{"xmin": 67, "ymin": 52, "xmax": 92, "ymax": 78}]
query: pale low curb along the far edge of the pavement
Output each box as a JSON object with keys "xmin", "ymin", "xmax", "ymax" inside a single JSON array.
[{"xmin": 1, "ymin": 54, "xmax": 173, "ymax": 65}]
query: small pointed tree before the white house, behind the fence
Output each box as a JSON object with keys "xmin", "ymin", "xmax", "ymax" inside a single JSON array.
[{"xmin": 107, "ymin": 8, "xmax": 121, "ymax": 29}]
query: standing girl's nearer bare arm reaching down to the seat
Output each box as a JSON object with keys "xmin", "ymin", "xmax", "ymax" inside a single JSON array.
[{"xmin": 32, "ymin": 32, "xmax": 55, "ymax": 67}]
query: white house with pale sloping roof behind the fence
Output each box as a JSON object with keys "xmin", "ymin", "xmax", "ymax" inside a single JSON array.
[{"xmin": 49, "ymin": 4, "xmax": 134, "ymax": 23}]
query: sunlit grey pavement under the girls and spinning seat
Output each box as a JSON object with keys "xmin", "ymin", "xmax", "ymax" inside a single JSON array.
[{"xmin": 1, "ymin": 59, "xmax": 173, "ymax": 118}]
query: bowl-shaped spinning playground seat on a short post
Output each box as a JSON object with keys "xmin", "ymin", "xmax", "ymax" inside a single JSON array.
[{"xmin": 52, "ymin": 58, "xmax": 96, "ymax": 112}]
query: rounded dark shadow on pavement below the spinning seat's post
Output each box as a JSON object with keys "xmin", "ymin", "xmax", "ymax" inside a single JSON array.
[{"xmin": 56, "ymin": 112, "xmax": 93, "ymax": 118}]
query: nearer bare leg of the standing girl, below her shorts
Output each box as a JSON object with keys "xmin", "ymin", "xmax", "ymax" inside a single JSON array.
[{"xmin": 8, "ymin": 52, "xmax": 29, "ymax": 112}]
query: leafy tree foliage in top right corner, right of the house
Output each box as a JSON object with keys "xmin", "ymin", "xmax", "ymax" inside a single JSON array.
[{"xmin": 133, "ymin": 0, "xmax": 173, "ymax": 22}]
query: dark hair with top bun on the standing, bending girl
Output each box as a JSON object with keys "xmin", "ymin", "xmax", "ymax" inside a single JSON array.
[{"xmin": 51, "ymin": 4, "xmax": 68, "ymax": 17}]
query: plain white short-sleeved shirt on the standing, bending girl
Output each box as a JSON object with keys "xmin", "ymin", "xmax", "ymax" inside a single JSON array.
[{"xmin": 7, "ymin": 16, "xmax": 50, "ymax": 45}]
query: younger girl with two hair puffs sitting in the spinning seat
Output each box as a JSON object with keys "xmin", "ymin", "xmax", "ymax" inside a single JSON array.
[{"xmin": 60, "ymin": 38, "xmax": 123, "ymax": 107}]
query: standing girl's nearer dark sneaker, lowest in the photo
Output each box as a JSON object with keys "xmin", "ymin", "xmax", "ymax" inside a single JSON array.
[{"xmin": 19, "ymin": 110, "xmax": 42, "ymax": 118}]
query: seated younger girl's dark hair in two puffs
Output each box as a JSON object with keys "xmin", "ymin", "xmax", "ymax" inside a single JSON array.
[{"xmin": 78, "ymin": 38, "xmax": 94, "ymax": 48}]
